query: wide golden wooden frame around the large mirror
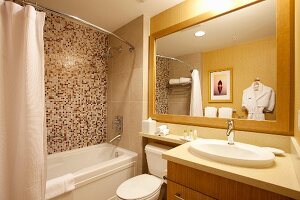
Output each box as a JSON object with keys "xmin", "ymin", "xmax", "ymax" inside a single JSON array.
[{"xmin": 148, "ymin": 0, "xmax": 294, "ymax": 135}]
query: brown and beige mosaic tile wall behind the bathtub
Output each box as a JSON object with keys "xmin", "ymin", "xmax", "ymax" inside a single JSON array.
[{"xmin": 44, "ymin": 13, "xmax": 108, "ymax": 154}]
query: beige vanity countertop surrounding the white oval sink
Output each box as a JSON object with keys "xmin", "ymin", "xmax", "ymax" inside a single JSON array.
[{"xmin": 163, "ymin": 142, "xmax": 300, "ymax": 199}]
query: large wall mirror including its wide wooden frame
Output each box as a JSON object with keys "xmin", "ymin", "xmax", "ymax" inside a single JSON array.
[{"xmin": 149, "ymin": 0, "xmax": 293, "ymax": 134}]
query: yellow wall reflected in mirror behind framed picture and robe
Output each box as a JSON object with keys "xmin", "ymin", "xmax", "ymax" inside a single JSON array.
[{"xmin": 202, "ymin": 37, "xmax": 276, "ymax": 120}]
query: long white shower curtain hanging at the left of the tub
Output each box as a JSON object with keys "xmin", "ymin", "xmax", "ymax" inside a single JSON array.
[{"xmin": 0, "ymin": 0, "xmax": 45, "ymax": 200}]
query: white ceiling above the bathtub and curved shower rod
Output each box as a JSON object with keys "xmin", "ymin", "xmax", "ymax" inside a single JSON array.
[{"xmin": 31, "ymin": 0, "xmax": 184, "ymax": 32}]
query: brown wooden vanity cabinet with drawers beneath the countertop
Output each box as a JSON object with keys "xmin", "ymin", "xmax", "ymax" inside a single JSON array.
[{"xmin": 167, "ymin": 161, "xmax": 292, "ymax": 200}]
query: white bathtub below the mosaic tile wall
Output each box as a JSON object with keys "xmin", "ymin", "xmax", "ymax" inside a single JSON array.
[{"xmin": 47, "ymin": 143, "xmax": 137, "ymax": 200}]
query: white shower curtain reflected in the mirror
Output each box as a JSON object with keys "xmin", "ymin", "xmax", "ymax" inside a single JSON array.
[{"xmin": 190, "ymin": 69, "xmax": 203, "ymax": 117}]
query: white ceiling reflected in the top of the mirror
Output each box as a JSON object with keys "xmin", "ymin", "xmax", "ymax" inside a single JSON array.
[{"xmin": 156, "ymin": 0, "xmax": 276, "ymax": 57}]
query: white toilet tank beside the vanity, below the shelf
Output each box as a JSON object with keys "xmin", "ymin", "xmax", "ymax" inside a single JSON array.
[{"xmin": 145, "ymin": 143, "xmax": 172, "ymax": 178}]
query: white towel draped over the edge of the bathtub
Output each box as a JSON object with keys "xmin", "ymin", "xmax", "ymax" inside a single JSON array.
[{"xmin": 45, "ymin": 174, "xmax": 75, "ymax": 199}]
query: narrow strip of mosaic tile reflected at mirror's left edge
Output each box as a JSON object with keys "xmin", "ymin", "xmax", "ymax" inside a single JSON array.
[{"xmin": 155, "ymin": 57, "xmax": 170, "ymax": 114}]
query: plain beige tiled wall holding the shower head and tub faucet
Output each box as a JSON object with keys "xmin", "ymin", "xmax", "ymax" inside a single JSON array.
[{"xmin": 108, "ymin": 16, "xmax": 147, "ymax": 173}]
